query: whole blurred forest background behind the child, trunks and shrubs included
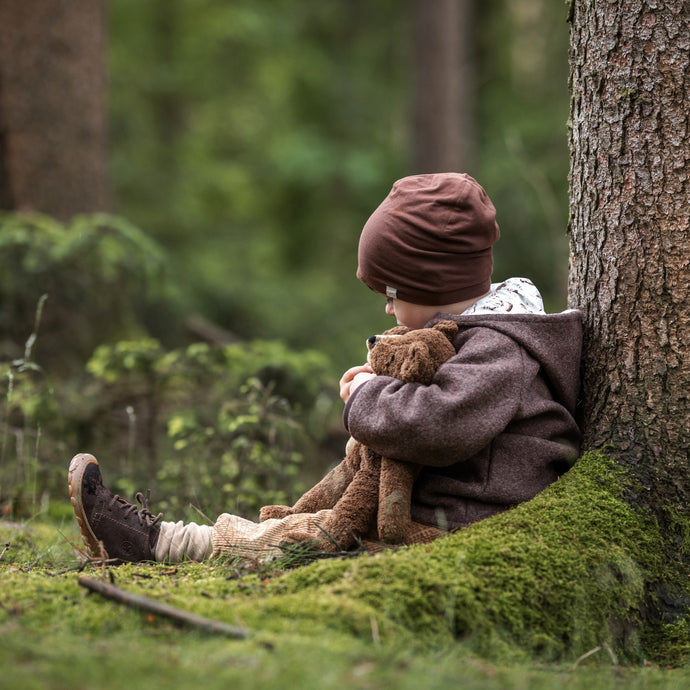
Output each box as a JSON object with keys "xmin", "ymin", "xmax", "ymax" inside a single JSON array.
[{"xmin": 0, "ymin": 0, "xmax": 568, "ymax": 515}]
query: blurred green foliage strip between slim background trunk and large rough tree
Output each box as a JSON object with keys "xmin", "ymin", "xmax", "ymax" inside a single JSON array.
[{"xmin": 476, "ymin": 0, "xmax": 569, "ymax": 311}]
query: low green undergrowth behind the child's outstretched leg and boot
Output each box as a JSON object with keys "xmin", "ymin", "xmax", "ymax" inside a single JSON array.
[{"xmin": 0, "ymin": 326, "xmax": 341, "ymax": 517}]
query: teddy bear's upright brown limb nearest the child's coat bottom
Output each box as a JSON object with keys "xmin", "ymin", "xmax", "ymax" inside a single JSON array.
[{"xmin": 377, "ymin": 458, "xmax": 421, "ymax": 544}]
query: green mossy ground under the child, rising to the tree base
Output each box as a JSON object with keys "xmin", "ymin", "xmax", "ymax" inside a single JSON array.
[{"xmin": 0, "ymin": 454, "xmax": 690, "ymax": 690}]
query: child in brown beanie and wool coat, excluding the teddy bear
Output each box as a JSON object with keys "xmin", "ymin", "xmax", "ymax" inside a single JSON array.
[{"xmin": 69, "ymin": 173, "xmax": 581, "ymax": 562}]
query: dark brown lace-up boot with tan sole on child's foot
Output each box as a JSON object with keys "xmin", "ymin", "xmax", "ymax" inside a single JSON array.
[{"xmin": 68, "ymin": 453, "xmax": 163, "ymax": 562}]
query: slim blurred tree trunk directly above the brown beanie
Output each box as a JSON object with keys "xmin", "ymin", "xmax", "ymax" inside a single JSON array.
[{"xmin": 412, "ymin": 0, "xmax": 475, "ymax": 173}]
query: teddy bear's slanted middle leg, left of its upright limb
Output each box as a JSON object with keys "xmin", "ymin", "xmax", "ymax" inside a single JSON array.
[{"xmin": 312, "ymin": 444, "xmax": 381, "ymax": 551}]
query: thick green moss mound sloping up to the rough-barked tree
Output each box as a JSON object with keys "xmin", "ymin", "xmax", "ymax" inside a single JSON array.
[{"xmin": 220, "ymin": 453, "xmax": 664, "ymax": 661}]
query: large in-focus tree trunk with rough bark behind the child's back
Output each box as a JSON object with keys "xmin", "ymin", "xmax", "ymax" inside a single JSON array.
[{"xmin": 569, "ymin": 0, "xmax": 690, "ymax": 514}]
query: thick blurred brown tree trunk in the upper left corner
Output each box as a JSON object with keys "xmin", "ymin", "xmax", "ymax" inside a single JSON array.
[{"xmin": 0, "ymin": 0, "xmax": 106, "ymax": 220}]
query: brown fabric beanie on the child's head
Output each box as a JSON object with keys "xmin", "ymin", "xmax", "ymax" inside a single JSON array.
[{"xmin": 357, "ymin": 173, "xmax": 499, "ymax": 306}]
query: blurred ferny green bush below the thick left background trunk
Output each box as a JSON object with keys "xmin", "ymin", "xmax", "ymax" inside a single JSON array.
[{"xmin": 0, "ymin": 213, "xmax": 170, "ymax": 370}]
